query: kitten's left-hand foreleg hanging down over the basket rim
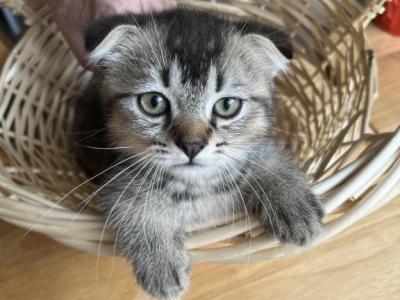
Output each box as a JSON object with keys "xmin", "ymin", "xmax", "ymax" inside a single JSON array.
[{"xmin": 108, "ymin": 197, "xmax": 191, "ymax": 299}]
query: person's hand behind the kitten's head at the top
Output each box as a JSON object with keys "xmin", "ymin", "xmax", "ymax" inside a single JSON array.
[{"xmin": 47, "ymin": 0, "xmax": 173, "ymax": 67}]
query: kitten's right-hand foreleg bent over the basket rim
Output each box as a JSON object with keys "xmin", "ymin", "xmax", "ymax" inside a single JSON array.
[{"xmin": 248, "ymin": 151, "xmax": 324, "ymax": 245}]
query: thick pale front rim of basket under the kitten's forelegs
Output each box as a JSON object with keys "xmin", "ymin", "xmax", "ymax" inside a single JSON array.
[{"xmin": 0, "ymin": 0, "xmax": 400, "ymax": 263}]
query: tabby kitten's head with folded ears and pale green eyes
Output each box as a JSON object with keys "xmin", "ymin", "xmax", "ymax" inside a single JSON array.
[{"xmin": 86, "ymin": 9, "xmax": 292, "ymax": 178}]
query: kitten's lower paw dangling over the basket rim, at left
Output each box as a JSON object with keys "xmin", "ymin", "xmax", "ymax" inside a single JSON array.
[{"xmin": 135, "ymin": 250, "xmax": 191, "ymax": 300}]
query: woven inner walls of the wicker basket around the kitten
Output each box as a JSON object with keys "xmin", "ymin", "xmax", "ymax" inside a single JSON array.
[{"xmin": 0, "ymin": 0, "xmax": 376, "ymax": 213}]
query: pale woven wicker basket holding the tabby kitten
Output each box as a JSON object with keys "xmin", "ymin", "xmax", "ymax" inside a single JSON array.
[{"xmin": 0, "ymin": 0, "xmax": 400, "ymax": 262}]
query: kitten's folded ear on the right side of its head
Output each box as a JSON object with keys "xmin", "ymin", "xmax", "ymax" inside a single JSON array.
[{"xmin": 236, "ymin": 22, "xmax": 293, "ymax": 76}]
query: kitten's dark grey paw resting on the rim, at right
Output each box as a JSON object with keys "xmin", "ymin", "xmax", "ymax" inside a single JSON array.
[{"xmin": 261, "ymin": 187, "xmax": 324, "ymax": 246}]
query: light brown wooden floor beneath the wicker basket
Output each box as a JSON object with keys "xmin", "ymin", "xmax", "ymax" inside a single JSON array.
[{"xmin": 0, "ymin": 28, "xmax": 400, "ymax": 300}]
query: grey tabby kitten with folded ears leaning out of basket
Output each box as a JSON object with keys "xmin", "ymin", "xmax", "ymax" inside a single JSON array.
[{"xmin": 75, "ymin": 9, "xmax": 324, "ymax": 298}]
